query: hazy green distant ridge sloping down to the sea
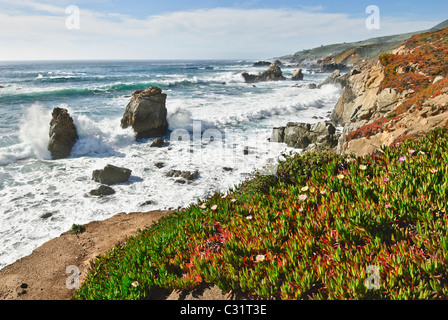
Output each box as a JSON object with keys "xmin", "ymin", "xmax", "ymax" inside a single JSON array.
[{"xmin": 276, "ymin": 20, "xmax": 448, "ymax": 65}]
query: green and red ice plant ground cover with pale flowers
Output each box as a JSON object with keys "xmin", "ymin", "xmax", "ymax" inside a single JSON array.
[{"xmin": 74, "ymin": 128, "xmax": 448, "ymax": 299}]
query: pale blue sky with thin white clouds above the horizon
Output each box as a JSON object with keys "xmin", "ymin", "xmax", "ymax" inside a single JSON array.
[{"xmin": 0, "ymin": 0, "xmax": 448, "ymax": 61}]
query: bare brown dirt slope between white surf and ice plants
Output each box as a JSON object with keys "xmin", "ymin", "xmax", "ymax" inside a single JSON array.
[{"xmin": 0, "ymin": 211, "xmax": 172, "ymax": 300}]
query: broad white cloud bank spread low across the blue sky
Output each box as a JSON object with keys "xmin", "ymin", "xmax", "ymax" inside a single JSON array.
[{"xmin": 0, "ymin": 0, "xmax": 436, "ymax": 60}]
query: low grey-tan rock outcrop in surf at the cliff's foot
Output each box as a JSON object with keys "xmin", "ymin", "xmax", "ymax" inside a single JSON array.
[{"xmin": 270, "ymin": 121, "xmax": 340, "ymax": 149}]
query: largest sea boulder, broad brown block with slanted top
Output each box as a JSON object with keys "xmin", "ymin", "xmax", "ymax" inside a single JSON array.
[{"xmin": 121, "ymin": 87, "xmax": 168, "ymax": 139}]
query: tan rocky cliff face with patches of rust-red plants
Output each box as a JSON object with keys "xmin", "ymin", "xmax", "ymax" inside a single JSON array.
[{"xmin": 332, "ymin": 28, "xmax": 448, "ymax": 155}]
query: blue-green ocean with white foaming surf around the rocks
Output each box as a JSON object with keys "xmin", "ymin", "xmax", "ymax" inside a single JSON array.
[{"xmin": 0, "ymin": 60, "xmax": 341, "ymax": 269}]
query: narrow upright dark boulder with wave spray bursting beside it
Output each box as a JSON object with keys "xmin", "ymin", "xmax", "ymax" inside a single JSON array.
[{"xmin": 48, "ymin": 108, "xmax": 78, "ymax": 159}]
